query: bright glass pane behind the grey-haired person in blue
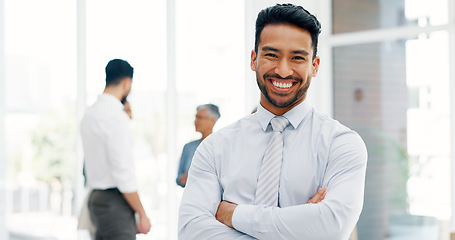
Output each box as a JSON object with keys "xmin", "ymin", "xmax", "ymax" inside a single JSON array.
[{"xmin": 173, "ymin": 0, "xmax": 246, "ymax": 221}]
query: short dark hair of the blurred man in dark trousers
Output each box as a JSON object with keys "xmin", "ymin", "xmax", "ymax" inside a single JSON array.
[{"xmin": 106, "ymin": 59, "xmax": 133, "ymax": 86}]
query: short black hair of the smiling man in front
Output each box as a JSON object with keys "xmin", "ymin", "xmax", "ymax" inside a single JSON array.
[{"xmin": 254, "ymin": 3, "xmax": 321, "ymax": 59}]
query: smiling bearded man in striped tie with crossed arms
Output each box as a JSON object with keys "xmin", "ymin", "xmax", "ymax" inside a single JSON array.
[{"xmin": 179, "ymin": 4, "xmax": 367, "ymax": 240}]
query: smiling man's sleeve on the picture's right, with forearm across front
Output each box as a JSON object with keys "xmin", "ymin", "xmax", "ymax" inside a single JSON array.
[{"xmin": 232, "ymin": 132, "xmax": 367, "ymax": 240}]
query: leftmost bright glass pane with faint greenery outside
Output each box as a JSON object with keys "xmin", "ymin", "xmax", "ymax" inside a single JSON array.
[{"xmin": 1, "ymin": 0, "xmax": 78, "ymax": 239}]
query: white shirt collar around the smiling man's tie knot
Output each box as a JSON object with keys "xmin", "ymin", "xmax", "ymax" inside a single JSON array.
[{"xmin": 257, "ymin": 101, "xmax": 310, "ymax": 131}]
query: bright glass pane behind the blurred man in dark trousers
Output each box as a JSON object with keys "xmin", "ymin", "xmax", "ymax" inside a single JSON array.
[{"xmin": 86, "ymin": 0, "xmax": 168, "ymax": 239}]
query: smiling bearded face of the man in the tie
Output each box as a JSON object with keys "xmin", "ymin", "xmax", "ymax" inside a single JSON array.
[{"xmin": 251, "ymin": 24, "xmax": 319, "ymax": 110}]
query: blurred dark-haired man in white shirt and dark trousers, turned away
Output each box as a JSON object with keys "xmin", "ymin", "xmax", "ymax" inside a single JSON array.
[{"xmin": 81, "ymin": 59, "xmax": 151, "ymax": 240}]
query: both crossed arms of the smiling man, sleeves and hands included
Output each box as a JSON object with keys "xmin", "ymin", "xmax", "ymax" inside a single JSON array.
[{"xmin": 179, "ymin": 132, "xmax": 366, "ymax": 240}]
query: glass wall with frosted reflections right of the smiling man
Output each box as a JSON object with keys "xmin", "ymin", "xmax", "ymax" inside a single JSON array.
[{"xmin": 332, "ymin": 0, "xmax": 452, "ymax": 240}]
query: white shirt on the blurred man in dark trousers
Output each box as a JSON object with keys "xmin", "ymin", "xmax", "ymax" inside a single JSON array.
[{"xmin": 81, "ymin": 93, "xmax": 137, "ymax": 193}]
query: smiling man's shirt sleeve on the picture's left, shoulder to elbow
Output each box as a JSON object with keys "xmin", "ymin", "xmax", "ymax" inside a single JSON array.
[{"xmin": 179, "ymin": 138, "xmax": 254, "ymax": 240}]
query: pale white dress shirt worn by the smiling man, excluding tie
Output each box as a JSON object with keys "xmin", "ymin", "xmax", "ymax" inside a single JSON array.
[{"xmin": 179, "ymin": 101, "xmax": 367, "ymax": 240}]
